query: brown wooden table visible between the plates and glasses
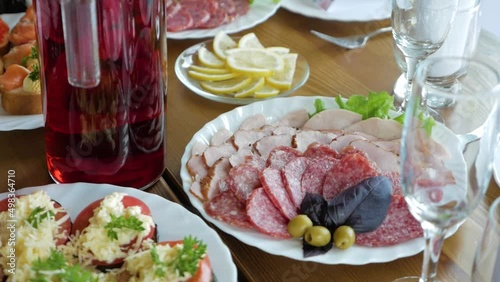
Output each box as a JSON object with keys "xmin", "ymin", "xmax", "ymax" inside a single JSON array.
[{"xmin": 0, "ymin": 9, "xmax": 500, "ymax": 282}]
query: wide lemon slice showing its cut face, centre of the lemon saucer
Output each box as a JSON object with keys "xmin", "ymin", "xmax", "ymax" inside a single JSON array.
[{"xmin": 226, "ymin": 48, "xmax": 285, "ymax": 76}]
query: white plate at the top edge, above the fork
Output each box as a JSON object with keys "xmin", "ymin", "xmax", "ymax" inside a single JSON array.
[{"xmin": 281, "ymin": 0, "xmax": 391, "ymax": 22}]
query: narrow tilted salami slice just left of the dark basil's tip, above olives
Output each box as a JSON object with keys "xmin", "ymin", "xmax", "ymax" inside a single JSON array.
[{"xmin": 281, "ymin": 157, "xmax": 309, "ymax": 209}]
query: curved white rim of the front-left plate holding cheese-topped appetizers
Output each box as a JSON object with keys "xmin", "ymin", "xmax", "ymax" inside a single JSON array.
[{"xmin": 0, "ymin": 182, "xmax": 238, "ymax": 282}]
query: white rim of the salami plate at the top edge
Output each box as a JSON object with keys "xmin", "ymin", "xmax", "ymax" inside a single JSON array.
[{"xmin": 167, "ymin": 0, "xmax": 280, "ymax": 39}]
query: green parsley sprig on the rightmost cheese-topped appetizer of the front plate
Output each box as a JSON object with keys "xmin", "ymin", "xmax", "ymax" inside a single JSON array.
[{"xmin": 151, "ymin": 236, "xmax": 207, "ymax": 277}]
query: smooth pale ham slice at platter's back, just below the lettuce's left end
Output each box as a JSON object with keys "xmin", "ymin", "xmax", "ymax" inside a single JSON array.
[{"xmin": 303, "ymin": 109, "xmax": 362, "ymax": 130}]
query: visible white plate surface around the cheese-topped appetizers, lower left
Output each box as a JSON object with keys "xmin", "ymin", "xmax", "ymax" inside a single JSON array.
[{"xmin": 0, "ymin": 183, "xmax": 237, "ymax": 281}]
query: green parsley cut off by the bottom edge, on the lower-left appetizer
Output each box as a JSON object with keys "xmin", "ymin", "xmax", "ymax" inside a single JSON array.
[{"xmin": 30, "ymin": 249, "xmax": 97, "ymax": 282}]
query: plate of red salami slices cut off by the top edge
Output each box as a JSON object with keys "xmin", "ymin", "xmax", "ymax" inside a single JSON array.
[{"xmin": 167, "ymin": 0, "xmax": 280, "ymax": 39}]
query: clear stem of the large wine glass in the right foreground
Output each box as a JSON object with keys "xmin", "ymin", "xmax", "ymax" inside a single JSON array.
[{"xmin": 420, "ymin": 222, "xmax": 446, "ymax": 282}]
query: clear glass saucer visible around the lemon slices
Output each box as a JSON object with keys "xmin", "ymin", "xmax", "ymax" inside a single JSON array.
[{"xmin": 175, "ymin": 40, "xmax": 309, "ymax": 105}]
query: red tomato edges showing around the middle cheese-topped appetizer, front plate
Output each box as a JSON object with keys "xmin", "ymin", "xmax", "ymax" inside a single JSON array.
[{"xmin": 71, "ymin": 195, "xmax": 156, "ymax": 269}]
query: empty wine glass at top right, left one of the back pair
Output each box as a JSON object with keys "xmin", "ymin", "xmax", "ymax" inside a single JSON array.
[{"xmin": 391, "ymin": 0, "xmax": 459, "ymax": 110}]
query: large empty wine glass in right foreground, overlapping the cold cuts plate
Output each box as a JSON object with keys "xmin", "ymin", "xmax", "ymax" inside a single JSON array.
[{"xmin": 396, "ymin": 57, "xmax": 500, "ymax": 282}]
